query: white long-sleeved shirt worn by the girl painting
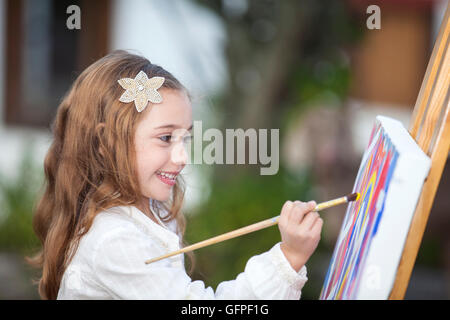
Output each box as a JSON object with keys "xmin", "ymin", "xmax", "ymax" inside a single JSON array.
[{"xmin": 57, "ymin": 206, "xmax": 308, "ymax": 299}]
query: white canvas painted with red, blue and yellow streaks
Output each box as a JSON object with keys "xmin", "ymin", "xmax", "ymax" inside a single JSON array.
[{"xmin": 320, "ymin": 116, "xmax": 431, "ymax": 299}]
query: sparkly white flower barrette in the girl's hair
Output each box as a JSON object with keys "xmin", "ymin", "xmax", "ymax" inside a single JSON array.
[{"xmin": 117, "ymin": 71, "xmax": 165, "ymax": 112}]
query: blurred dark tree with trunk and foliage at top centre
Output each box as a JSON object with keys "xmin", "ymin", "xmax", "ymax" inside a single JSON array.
[{"xmin": 198, "ymin": 0, "xmax": 361, "ymax": 181}]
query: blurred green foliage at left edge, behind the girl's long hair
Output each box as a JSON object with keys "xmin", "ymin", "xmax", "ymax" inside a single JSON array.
[{"xmin": 0, "ymin": 144, "xmax": 43, "ymax": 254}]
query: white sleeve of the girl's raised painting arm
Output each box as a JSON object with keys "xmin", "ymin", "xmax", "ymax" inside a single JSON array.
[{"xmin": 93, "ymin": 228, "xmax": 308, "ymax": 300}]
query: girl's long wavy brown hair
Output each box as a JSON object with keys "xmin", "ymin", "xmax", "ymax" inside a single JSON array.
[{"xmin": 27, "ymin": 50, "xmax": 192, "ymax": 299}]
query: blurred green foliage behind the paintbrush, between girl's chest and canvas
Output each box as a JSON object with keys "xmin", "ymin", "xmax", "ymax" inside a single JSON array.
[{"xmin": 186, "ymin": 167, "xmax": 313, "ymax": 298}]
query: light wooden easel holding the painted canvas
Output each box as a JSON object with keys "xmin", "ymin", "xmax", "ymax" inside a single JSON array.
[{"xmin": 389, "ymin": 4, "xmax": 450, "ymax": 300}]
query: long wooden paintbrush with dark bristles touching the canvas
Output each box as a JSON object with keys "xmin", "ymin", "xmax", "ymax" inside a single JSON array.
[{"xmin": 145, "ymin": 192, "xmax": 360, "ymax": 264}]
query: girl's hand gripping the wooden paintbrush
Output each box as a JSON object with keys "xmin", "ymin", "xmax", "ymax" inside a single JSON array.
[{"xmin": 278, "ymin": 201, "xmax": 323, "ymax": 272}]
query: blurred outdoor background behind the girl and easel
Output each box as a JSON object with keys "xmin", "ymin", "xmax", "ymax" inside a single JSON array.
[{"xmin": 0, "ymin": 0, "xmax": 450, "ymax": 299}]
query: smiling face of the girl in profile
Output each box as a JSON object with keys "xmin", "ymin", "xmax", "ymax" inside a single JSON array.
[{"xmin": 134, "ymin": 88, "xmax": 192, "ymax": 203}]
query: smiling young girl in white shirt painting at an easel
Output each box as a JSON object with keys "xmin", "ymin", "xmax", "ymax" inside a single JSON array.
[{"xmin": 30, "ymin": 51, "xmax": 322, "ymax": 299}]
